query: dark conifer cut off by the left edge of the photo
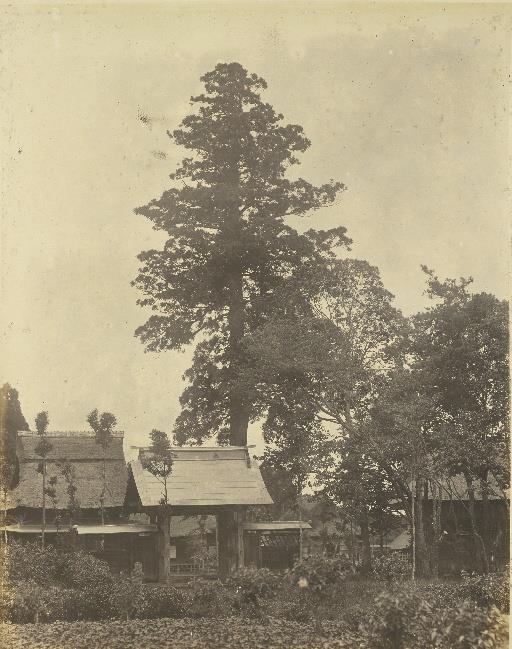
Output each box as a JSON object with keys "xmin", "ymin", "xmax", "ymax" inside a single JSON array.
[{"xmin": 0, "ymin": 383, "xmax": 28, "ymax": 540}]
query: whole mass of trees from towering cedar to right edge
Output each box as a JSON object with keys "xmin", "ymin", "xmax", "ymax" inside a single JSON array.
[{"xmin": 133, "ymin": 63, "xmax": 509, "ymax": 575}]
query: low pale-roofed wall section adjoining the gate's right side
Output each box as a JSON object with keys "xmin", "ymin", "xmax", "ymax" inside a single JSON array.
[{"xmin": 242, "ymin": 521, "xmax": 311, "ymax": 570}]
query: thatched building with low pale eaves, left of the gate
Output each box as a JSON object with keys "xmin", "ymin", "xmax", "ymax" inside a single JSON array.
[{"xmin": 6, "ymin": 431, "xmax": 157, "ymax": 580}]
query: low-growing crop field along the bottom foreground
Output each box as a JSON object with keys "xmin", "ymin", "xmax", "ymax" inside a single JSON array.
[{"xmin": 0, "ymin": 618, "xmax": 364, "ymax": 649}]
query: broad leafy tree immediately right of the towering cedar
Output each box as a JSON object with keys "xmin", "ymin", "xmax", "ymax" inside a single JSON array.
[{"xmin": 248, "ymin": 259, "xmax": 407, "ymax": 569}]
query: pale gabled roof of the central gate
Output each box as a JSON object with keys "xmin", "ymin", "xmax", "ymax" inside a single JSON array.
[{"xmin": 130, "ymin": 446, "xmax": 272, "ymax": 507}]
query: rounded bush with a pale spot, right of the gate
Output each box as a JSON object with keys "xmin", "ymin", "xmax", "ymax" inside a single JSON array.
[{"xmin": 287, "ymin": 555, "xmax": 353, "ymax": 593}]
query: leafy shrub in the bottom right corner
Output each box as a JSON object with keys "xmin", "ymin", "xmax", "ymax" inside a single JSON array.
[{"xmin": 430, "ymin": 602, "xmax": 507, "ymax": 649}]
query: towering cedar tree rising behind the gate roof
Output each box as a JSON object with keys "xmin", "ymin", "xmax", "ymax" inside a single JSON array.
[{"xmin": 134, "ymin": 63, "xmax": 349, "ymax": 445}]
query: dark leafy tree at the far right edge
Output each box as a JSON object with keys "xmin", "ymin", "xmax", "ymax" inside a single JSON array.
[{"xmin": 413, "ymin": 268, "xmax": 510, "ymax": 569}]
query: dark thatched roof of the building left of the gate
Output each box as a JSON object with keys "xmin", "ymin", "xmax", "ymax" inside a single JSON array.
[{"xmin": 9, "ymin": 432, "xmax": 127, "ymax": 509}]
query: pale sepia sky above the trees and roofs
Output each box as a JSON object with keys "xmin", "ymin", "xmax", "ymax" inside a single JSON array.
[{"xmin": 0, "ymin": 1, "xmax": 511, "ymax": 455}]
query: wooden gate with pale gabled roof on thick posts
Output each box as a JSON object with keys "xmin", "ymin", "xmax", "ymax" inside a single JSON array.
[{"xmin": 126, "ymin": 446, "xmax": 272, "ymax": 581}]
